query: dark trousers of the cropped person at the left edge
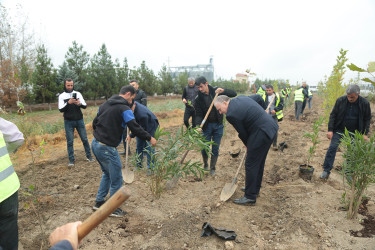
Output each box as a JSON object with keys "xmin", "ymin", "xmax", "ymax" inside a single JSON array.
[{"xmin": 0, "ymin": 191, "xmax": 18, "ymax": 250}]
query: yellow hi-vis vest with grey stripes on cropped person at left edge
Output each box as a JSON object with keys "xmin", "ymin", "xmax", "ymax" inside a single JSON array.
[{"xmin": 0, "ymin": 131, "xmax": 20, "ymax": 203}]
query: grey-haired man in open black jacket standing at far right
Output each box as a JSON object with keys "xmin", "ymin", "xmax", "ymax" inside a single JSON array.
[{"xmin": 320, "ymin": 85, "xmax": 371, "ymax": 179}]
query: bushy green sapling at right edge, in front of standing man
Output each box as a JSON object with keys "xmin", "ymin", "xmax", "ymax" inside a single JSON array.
[{"xmin": 341, "ymin": 129, "xmax": 375, "ymax": 219}]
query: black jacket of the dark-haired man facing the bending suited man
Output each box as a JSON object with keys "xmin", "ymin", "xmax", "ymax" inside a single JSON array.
[{"xmin": 194, "ymin": 85, "xmax": 237, "ymax": 129}]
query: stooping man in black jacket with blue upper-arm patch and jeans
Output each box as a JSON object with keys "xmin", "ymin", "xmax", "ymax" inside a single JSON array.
[{"xmin": 91, "ymin": 85, "xmax": 157, "ymax": 217}]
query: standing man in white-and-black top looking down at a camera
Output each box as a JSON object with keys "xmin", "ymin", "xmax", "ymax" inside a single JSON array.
[{"xmin": 59, "ymin": 78, "xmax": 94, "ymax": 167}]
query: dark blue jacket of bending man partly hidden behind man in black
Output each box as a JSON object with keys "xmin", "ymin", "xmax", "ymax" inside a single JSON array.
[{"xmin": 130, "ymin": 102, "xmax": 159, "ymax": 138}]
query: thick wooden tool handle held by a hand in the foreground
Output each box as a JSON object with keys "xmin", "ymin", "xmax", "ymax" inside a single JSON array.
[{"xmin": 77, "ymin": 187, "xmax": 131, "ymax": 241}]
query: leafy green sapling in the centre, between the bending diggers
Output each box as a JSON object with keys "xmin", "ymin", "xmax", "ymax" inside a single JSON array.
[{"xmin": 149, "ymin": 126, "xmax": 213, "ymax": 198}]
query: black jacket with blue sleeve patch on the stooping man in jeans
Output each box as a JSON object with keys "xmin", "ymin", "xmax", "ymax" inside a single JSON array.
[{"xmin": 92, "ymin": 95, "xmax": 151, "ymax": 147}]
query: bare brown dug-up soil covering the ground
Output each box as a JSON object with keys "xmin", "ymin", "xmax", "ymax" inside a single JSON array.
[{"xmin": 13, "ymin": 95, "xmax": 375, "ymax": 249}]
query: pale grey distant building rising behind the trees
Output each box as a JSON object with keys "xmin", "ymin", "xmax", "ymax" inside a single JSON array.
[{"xmin": 169, "ymin": 57, "xmax": 214, "ymax": 82}]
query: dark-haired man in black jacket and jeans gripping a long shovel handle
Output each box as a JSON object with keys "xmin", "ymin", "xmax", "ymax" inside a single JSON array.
[{"xmin": 194, "ymin": 76, "xmax": 237, "ymax": 176}]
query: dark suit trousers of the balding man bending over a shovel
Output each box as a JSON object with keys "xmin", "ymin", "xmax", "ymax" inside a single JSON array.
[{"xmin": 245, "ymin": 130, "xmax": 273, "ymax": 200}]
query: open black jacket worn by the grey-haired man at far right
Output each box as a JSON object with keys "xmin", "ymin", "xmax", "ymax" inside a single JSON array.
[{"xmin": 328, "ymin": 95, "xmax": 371, "ymax": 135}]
